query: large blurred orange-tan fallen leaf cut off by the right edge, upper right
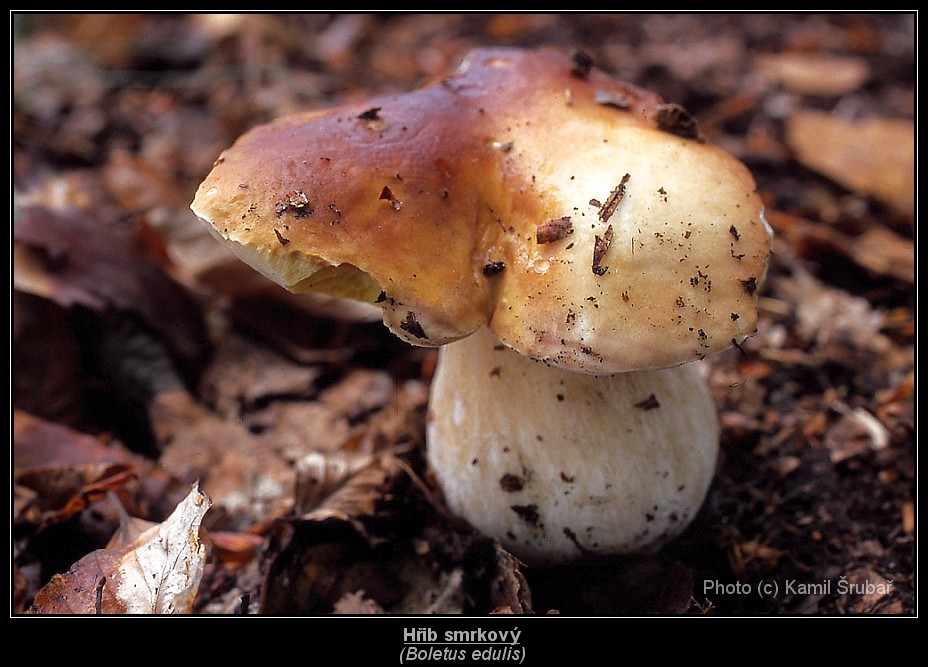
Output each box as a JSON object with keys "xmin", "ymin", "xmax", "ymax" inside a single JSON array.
[{"xmin": 786, "ymin": 111, "xmax": 915, "ymax": 216}]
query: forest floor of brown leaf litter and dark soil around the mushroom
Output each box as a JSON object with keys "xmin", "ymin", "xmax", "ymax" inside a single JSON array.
[{"xmin": 11, "ymin": 13, "xmax": 917, "ymax": 616}]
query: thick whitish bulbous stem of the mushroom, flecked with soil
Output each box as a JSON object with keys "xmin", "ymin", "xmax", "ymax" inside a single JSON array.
[{"xmin": 427, "ymin": 329, "xmax": 719, "ymax": 564}]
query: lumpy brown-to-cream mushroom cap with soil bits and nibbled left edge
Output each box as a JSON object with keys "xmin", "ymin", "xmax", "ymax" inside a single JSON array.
[{"xmin": 192, "ymin": 48, "xmax": 770, "ymax": 374}]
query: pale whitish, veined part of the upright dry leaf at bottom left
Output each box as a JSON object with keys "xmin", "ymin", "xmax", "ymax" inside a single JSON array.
[{"xmin": 116, "ymin": 485, "xmax": 210, "ymax": 614}]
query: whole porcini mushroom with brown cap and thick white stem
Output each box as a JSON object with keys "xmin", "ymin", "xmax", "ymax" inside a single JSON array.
[{"xmin": 191, "ymin": 48, "xmax": 770, "ymax": 563}]
